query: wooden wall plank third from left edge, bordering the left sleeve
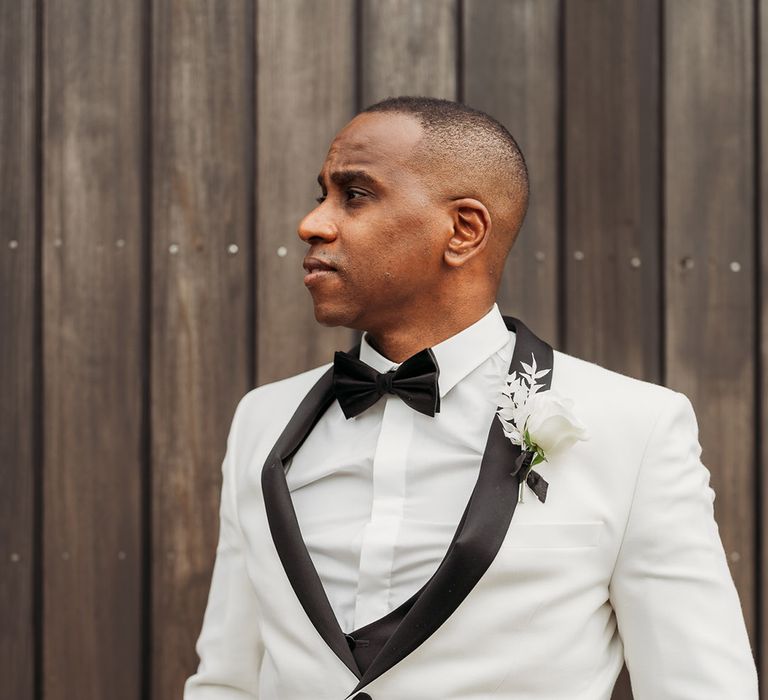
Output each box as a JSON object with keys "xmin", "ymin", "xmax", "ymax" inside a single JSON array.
[{"xmin": 151, "ymin": 0, "xmax": 254, "ymax": 699}]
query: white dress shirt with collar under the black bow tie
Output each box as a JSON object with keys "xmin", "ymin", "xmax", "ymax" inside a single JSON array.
[{"xmin": 286, "ymin": 304, "xmax": 515, "ymax": 632}]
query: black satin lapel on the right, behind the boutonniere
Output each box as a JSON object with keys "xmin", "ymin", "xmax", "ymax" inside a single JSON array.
[{"xmin": 350, "ymin": 316, "xmax": 554, "ymax": 695}]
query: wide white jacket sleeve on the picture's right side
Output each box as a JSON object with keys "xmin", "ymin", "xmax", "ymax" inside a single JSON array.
[{"xmin": 610, "ymin": 392, "xmax": 758, "ymax": 700}]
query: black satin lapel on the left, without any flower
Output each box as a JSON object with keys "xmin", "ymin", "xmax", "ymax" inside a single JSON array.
[{"xmin": 261, "ymin": 368, "xmax": 360, "ymax": 678}]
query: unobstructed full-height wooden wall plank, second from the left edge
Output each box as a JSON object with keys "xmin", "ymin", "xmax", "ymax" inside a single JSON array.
[{"xmin": 42, "ymin": 0, "xmax": 144, "ymax": 700}]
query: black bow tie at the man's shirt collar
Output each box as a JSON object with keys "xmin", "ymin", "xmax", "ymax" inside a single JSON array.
[{"xmin": 333, "ymin": 348, "xmax": 440, "ymax": 418}]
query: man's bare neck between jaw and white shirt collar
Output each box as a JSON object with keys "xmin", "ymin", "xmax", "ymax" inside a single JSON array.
[{"xmin": 366, "ymin": 304, "xmax": 493, "ymax": 364}]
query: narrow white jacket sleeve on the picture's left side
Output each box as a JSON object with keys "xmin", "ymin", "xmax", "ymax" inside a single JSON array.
[{"xmin": 184, "ymin": 400, "xmax": 263, "ymax": 700}]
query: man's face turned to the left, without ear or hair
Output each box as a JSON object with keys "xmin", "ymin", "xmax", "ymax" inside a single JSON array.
[{"xmin": 298, "ymin": 113, "xmax": 452, "ymax": 331}]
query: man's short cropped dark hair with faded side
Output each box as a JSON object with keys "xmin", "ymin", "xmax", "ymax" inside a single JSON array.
[{"xmin": 362, "ymin": 96, "xmax": 529, "ymax": 249}]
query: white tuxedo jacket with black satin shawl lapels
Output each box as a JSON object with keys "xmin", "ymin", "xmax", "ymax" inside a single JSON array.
[{"xmin": 184, "ymin": 318, "xmax": 757, "ymax": 700}]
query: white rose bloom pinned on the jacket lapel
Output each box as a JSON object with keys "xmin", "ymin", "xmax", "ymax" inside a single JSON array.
[{"xmin": 525, "ymin": 389, "xmax": 589, "ymax": 460}]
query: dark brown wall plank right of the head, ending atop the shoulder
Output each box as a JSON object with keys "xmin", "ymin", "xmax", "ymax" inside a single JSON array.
[{"xmin": 562, "ymin": 0, "xmax": 662, "ymax": 382}]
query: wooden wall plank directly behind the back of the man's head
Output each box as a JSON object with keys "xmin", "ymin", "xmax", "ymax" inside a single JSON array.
[{"xmin": 462, "ymin": 0, "xmax": 560, "ymax": 346}]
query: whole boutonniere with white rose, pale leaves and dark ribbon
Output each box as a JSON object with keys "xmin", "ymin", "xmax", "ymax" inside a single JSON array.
[{"xmin": 496, "ymin": 354, "xmax": 589, "ymax": 503}]
